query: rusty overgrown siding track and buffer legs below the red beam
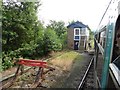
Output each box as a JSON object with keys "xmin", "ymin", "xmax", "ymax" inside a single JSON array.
[{"xmin": 0, "ymin": 60, "xmax": 55, "ymax": 89}]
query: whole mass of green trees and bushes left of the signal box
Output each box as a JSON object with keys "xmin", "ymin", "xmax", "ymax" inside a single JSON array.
[{"xmin": 0, "ymin": 0, "xmax": 67, "ymax": 70}]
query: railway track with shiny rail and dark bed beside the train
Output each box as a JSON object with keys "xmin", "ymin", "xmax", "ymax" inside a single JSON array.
[{"xmin": 78, "ymin": 58, "xmax": 94, "ymax": 90}]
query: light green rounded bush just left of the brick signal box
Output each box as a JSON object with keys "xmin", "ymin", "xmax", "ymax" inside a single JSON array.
[{"xmin": 44, "ymin": 28, "xmax": 62, "ymax": 55}]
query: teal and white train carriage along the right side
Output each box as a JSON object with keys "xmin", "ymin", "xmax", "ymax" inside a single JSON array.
[{"xmin": 94, "ymin": 0, "xmax": 120, "ymax": 89}]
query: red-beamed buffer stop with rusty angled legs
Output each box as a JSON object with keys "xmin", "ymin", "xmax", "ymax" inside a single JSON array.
[{"xmin": 3, "ymin": 59, "xmax": 55, "ymax": 88}]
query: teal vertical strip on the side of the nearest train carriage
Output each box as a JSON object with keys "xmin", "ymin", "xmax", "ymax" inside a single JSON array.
[{"xmin": 101, "ymin": 24, "xmax": 113, "ymax": 90}]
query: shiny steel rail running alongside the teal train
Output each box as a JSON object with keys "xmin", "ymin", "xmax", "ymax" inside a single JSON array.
[{"xmin": 77, "ymin": 58, "xmax": 94, "ymax": 90}]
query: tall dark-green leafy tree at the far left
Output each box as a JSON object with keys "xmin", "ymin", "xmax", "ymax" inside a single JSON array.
[{"xmin": 2, "ymin": 2, "xmax": 39, "ymax": 52}]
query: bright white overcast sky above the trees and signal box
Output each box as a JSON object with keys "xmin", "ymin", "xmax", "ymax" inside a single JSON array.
[{"xmin": 38, "ymin": 0, "xmax": 110, "ymax": 31}]
